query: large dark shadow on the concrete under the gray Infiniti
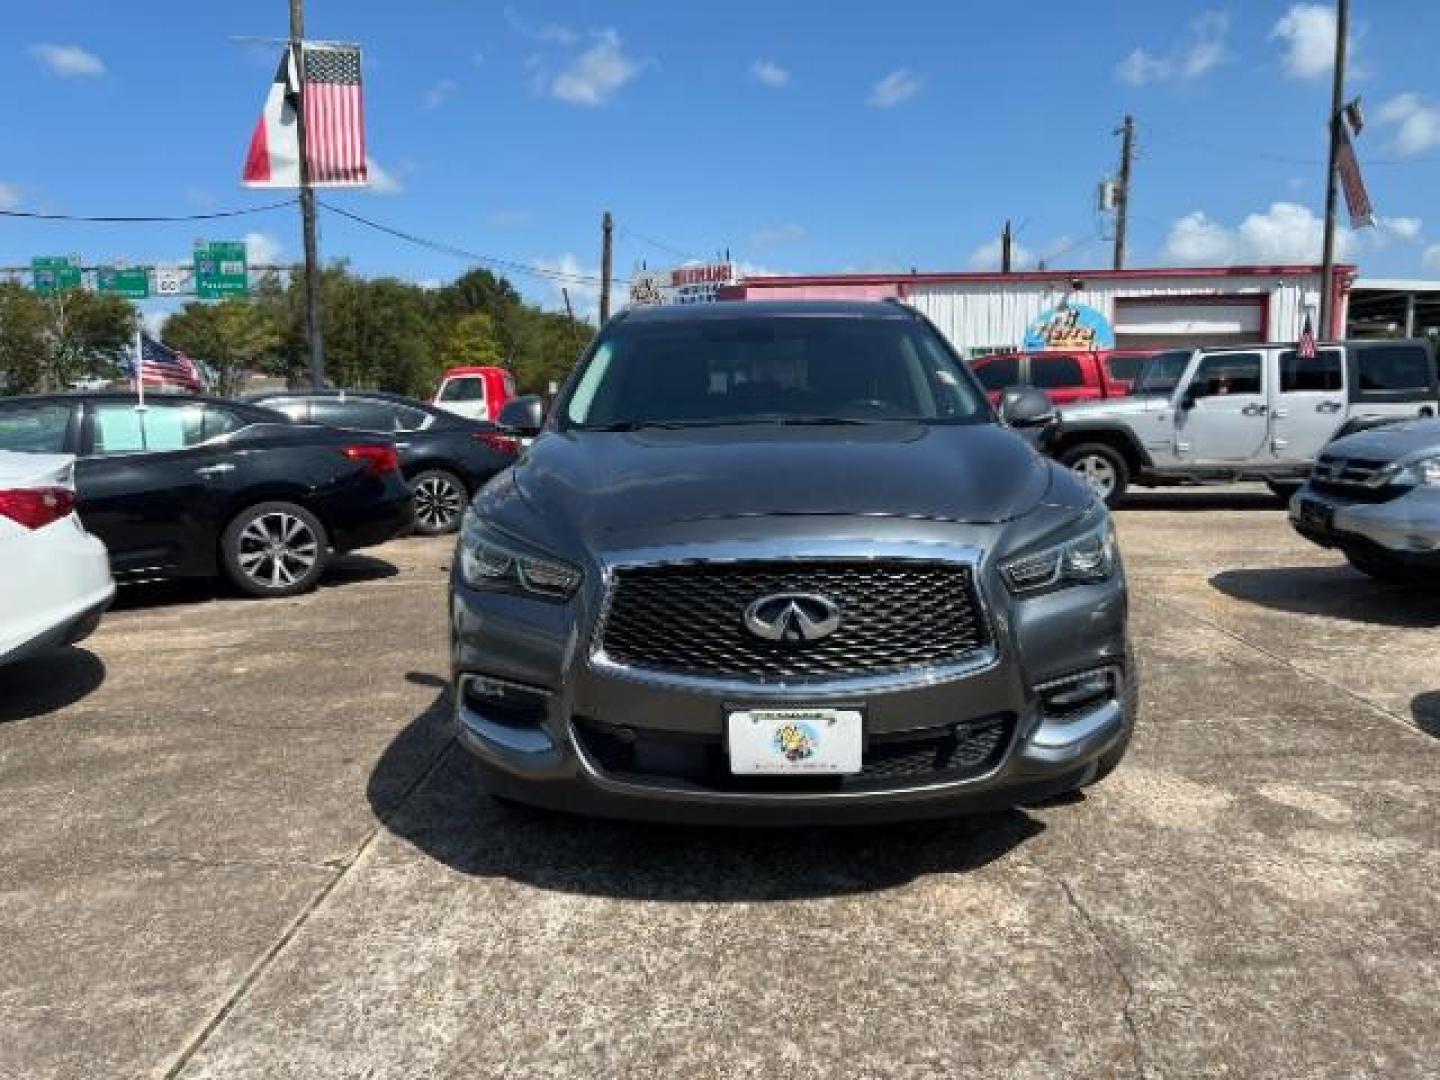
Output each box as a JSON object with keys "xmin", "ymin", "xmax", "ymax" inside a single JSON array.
[{"xmin": 367, "ymin": 694, "xmax": 1044, "ymax": 903}]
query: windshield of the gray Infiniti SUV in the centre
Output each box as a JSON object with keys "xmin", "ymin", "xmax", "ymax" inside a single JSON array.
[{"xmin": 560, "ymin": 315, "xmax": 991, "ymax": 429}]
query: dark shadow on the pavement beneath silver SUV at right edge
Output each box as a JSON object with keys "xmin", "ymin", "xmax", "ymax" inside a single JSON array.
[{"xmin": 1210, "ymin": 566, "xmax": 1440, "ymax": 629}]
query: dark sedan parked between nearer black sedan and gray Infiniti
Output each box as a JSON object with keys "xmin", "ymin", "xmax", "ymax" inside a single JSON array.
[{"xmin": 246, "ymin": 390, "xmax": 518, "ymax": 536}]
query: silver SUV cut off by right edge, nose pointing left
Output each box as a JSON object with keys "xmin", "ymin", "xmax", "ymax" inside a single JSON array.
[{"xmin": 1290, "ymin": 420, "xmax": 1440, "ymax": 583}]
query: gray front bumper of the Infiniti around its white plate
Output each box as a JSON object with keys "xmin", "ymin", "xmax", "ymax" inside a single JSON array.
[{"xmin": 451, "ymin": 541, "xmax": 1135, "ymax": 824}]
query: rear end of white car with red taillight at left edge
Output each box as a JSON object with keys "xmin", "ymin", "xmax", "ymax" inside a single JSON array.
[{"xmin": 0, "ymin": 451, "xmax": 115, "ymax": 664}]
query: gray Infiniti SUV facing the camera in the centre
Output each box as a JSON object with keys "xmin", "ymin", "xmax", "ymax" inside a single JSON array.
[{"xmin": 451, "ymin": 302, "xmax": 1136, "ymax": 824}]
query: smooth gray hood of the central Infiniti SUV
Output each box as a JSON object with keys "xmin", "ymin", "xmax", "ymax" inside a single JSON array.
[{"xmin": 513, "ymin": 423, "xmax": 1050, "ymax": 539}]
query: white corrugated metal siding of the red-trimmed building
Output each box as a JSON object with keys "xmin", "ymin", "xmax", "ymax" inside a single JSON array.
[{"xmin": 910, "ymin": 274, "xmax": 1320, "ymax": 348}]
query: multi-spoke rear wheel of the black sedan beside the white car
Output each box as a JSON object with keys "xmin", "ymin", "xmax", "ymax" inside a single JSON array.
[{"xmin": 220, "ymin": 503, "xmax": 330, "ymax": 596}]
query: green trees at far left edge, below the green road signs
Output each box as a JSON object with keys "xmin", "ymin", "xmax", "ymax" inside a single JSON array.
[{"xmin": 0, "ymin": 282, "xmax": 140, "ymax": 393}]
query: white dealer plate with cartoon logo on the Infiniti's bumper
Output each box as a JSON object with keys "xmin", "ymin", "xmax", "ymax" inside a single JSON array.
[{"xmin": 727, "ymin": 708, "xmax": 864, "ymax": 776}]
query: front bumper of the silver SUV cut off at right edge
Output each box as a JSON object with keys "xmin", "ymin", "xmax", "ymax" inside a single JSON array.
[{"xmin": 1289, "ymin": 482, "xmax": 1440, "ymax": 566}]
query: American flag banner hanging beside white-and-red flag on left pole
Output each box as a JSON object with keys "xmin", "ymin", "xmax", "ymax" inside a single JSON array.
[{"xmin": 301, "ymin": 45, "xmax": 367, "ymax": 186}]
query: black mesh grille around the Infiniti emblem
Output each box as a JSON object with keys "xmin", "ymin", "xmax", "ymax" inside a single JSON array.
[{"xmin": 600, "ymin": 559, "xmax": 989, "ymax": 683}]
